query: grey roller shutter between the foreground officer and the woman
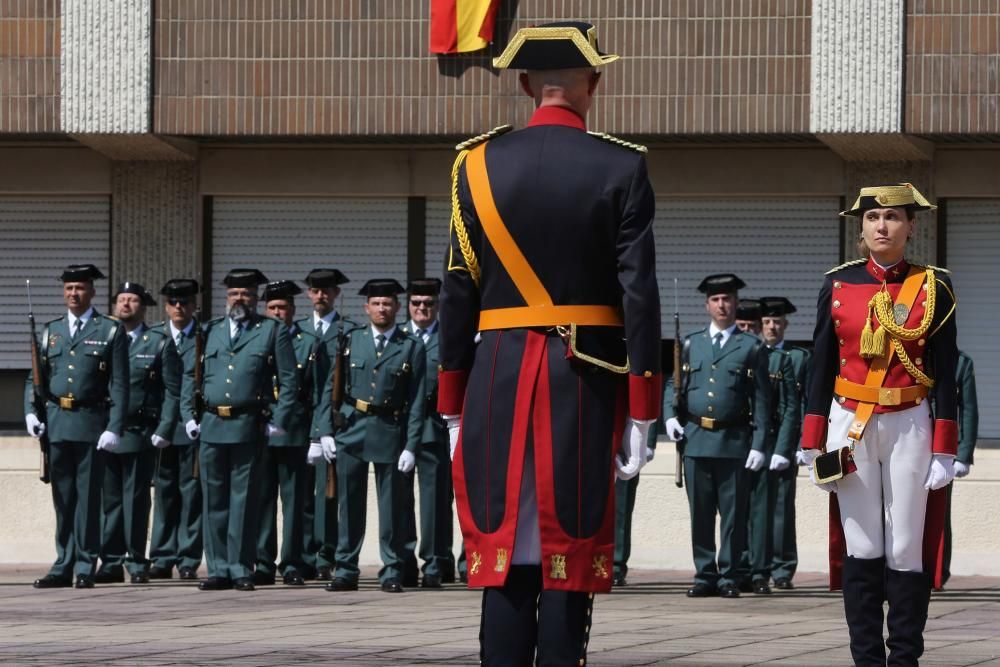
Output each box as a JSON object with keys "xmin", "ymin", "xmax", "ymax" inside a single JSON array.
[{"xmin": 654, "ymin": 198, "xmax": 840, "ymax": 341}]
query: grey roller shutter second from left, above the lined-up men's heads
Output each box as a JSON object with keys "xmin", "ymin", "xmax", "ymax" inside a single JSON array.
[{"xmin": 208, "ymin": 197, "xmax": 407, "ymax": 321}]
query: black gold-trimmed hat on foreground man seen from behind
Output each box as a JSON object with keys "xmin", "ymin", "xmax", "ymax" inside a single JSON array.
[{"xmin": 493, "ymin": 21, "xmax": 618, "ymax": 69}]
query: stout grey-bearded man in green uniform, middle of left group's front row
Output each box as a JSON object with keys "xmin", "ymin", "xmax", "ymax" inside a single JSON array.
[{"xmin": 181, "ymin": 269, "xmax": 298, "ymax": 591}]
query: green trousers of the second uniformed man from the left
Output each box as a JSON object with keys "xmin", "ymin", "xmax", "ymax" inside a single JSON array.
[{"xmin": 99, "ymin": 448, "xmax": 157, "ymax": 574}]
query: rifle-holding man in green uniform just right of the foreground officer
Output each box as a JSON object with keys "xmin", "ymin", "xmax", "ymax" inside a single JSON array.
[{"xmin": 664, "ymin": 273, "xmax": 771, "ymax": 598}]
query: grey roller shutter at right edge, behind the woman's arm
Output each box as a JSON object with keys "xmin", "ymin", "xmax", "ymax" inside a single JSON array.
[{"xmin": 946, "ymin": 199, "xmax": 1000, "ymax": 438}]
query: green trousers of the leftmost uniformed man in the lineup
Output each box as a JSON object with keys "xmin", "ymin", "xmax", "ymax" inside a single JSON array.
[{"xmin": 49, "ymin": 441, "xmax": 109, "ymax": 579}]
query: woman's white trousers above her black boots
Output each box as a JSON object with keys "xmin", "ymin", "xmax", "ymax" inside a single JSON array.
[{"xmin": 826, "ymin": 401, "xmax": 933, "ymax": 572}]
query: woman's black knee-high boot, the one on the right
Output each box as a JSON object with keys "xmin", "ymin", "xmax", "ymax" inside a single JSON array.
[{"xmin": 886, "ymin": 570, "xmax": 931, "ymax": 667}]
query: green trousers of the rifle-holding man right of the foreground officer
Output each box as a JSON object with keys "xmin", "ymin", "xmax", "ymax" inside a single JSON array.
[{"xmin": 684, "ymin": 456, "xmax": 750, "ymax": 586}]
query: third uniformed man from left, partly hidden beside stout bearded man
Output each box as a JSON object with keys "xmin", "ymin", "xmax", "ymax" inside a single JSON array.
[{"xmin": 149, "ymin": 278, "xmax": 202, "ymax": 580}]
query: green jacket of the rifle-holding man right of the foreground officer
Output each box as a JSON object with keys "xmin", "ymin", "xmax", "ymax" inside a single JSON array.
[{"xmin": 664, "ymin": 328, "xmax": 771, "ymax": 459}]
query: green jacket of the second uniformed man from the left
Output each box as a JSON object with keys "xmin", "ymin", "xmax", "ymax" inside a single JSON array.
[{"xmin": 115, "ymin": 325, "xmax": 182, "ymax": 454}]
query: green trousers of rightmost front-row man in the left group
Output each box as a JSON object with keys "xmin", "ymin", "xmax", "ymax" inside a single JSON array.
[{"xmin": 334, "ymin": 452, "xmax": 405, "ymax": 582}]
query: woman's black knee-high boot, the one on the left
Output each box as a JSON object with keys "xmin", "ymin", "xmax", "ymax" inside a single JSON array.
[{"xmin": 843, "ymin": 556, "xmax": 885, "ymax": 667}]
